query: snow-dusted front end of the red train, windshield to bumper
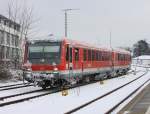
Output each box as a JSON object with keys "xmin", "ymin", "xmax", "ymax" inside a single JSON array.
[{"xmin": 23, "ymin": 40, "xmax": 62, "ymax": 88}]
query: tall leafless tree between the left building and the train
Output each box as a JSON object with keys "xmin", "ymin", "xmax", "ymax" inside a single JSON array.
[{"xmin": 7, "ymin": 0, "xmax": 37, "ymax": 68}]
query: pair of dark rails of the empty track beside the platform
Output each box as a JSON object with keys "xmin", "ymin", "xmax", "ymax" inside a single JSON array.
[{"xmin": 64, "ymin": 72, "xmax": 150, "ymax": 114}]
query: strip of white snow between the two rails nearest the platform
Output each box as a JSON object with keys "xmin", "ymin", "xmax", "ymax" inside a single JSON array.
[{"xmin": 76, "ymin": 71, "xmax": 149, "ymax": 114}]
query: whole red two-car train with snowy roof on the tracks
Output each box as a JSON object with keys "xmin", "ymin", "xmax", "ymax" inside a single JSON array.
[{"xmin": 24, "ymin": 39, "xmax": 131, "ymax": 88}]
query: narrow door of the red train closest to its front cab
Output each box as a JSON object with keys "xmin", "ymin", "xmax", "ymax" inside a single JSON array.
[{"xmin": 66, "ymin": 44, "xmax": 73, "ymax": 77}]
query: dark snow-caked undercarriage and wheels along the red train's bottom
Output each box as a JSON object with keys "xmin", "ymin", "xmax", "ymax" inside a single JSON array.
[{"xmin": 23, "ymin": 67, "xmax": 129, "ymax": 89}]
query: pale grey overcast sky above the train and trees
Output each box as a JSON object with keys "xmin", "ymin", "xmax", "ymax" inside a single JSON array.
[{"xmin": 0, "ymin": 0, "xmax": 150, "ymax": 47}]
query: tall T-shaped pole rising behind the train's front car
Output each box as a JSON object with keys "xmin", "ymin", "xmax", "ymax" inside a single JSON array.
[{"xmin": 63, "ymin": 9, "xmax": 79, "ymax": 37}]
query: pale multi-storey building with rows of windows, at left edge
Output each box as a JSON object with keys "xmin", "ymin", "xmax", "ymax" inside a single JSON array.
[{"xmin": 0, "ymin": 15, "xmax": 22, "ymax": 68}]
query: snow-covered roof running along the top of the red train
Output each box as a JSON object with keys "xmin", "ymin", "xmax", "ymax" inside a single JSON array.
[{"xmin": 29, "ymin": 36, "xmax": 130, "ymax": 54}]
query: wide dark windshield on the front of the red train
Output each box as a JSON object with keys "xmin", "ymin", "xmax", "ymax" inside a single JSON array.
[{"xmin": 28, "ymin": 42, "xmax": 61, "ymax": 65}]
